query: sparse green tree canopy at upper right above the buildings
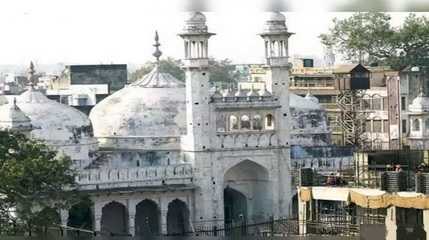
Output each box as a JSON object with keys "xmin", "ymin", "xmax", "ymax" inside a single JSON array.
[{"xmin": 320, "ymin": 12, "xmax": 429, "ymax": 69}]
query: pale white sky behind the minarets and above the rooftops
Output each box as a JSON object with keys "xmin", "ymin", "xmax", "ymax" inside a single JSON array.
[{"xmin": 0, "ymin": 0, "xmax": 426, "ymax": 64}]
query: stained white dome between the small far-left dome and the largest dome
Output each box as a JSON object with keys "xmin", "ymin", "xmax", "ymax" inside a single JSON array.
[{"xmin": 17, "ymin": 89, "xmax": 92, "ymax": 142}]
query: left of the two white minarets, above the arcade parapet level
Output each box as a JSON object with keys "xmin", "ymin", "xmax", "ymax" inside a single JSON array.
[{"xmin": 179, "ymin": 12, "xmax": 214, "ymax": 151}]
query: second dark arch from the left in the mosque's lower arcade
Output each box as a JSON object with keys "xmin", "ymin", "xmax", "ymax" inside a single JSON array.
[{"xmin": 101, "ymin": 202, "xmax": 128, "ymax": 235}]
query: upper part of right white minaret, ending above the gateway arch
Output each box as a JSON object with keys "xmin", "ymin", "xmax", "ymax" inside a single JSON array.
[{"xmin": 260, "ymin": 12, "xmax": 292, "ymax": 146}]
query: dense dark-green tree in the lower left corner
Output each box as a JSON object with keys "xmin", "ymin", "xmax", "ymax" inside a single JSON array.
[{"xmin": 0, "ymin": 131, "xmax": 75, "ymax": 231}]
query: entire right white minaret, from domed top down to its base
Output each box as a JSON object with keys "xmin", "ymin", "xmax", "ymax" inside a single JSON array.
[{"xmin": 260, "ymin": 12, "xmax": 292, "ymax": 216}]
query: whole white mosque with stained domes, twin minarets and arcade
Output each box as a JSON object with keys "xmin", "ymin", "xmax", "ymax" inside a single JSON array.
[{"xmin": 0, "ymin": 12, "xmax": 329, "ymax": 236}]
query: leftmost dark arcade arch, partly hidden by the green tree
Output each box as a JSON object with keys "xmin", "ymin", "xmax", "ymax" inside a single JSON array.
[{"xmin": 67, "ymin": 198, "xmax": 93, "ymax": 230}]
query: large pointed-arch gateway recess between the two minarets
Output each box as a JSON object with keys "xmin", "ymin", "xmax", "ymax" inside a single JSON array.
[{"xmin": 224, "ymin": 160, "xmax": 273, "ymax": 223}]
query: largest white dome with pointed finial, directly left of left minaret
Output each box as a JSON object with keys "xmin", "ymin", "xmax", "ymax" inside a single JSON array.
[{"xmin": 90, "ymin": 68, "xmax": 186, "ymax": 137}]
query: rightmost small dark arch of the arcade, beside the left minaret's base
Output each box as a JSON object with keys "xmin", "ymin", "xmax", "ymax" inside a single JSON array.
[{"xmin": 167, "ymin": 199, "xmax": 191, "ymax": 235}]
